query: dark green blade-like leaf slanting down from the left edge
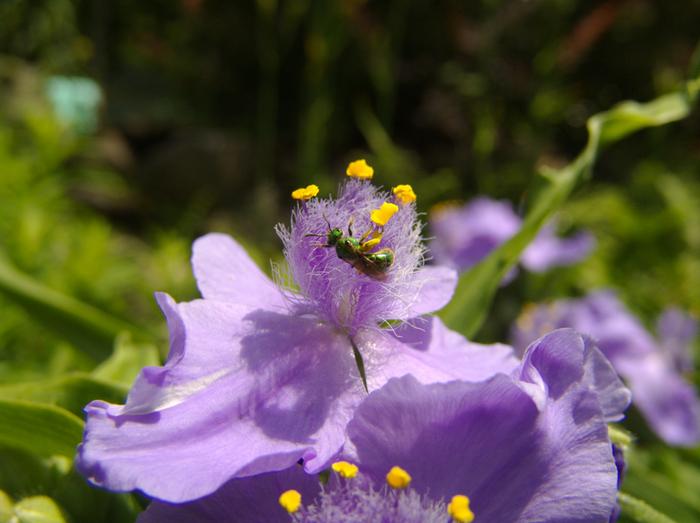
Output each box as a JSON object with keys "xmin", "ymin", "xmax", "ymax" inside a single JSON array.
[{"xmin": 0, "ymin": 253, "xmax": 151, "ymax": 359}]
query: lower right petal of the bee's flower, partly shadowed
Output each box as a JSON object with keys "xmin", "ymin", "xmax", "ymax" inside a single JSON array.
[{"xmin": 355, "ymin": 316, "xmax": 518, "ymax": 390}]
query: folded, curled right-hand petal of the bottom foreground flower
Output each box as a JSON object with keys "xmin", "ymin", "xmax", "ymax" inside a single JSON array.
[{"xmin": 518, "ymin": 329, "xmax": 630, "ymax": 523}]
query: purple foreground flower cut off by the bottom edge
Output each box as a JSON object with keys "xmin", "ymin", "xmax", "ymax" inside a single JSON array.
[{"xmin": 139, "ymin": 329, "xmax": 629, "ymax": 523}]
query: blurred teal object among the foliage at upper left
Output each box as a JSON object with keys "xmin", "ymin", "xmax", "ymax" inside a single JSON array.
[{"xmin": 46, "ymin": 76, "xmax": 103, "ymax": 135}]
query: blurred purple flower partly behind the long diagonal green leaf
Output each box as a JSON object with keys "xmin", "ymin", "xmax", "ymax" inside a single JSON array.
[{"xmin": 430, "ymin": 197, "xmax": 594, "ymax": 272}]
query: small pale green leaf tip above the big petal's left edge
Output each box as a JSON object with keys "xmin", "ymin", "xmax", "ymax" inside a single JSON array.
[{"xmin": 92, "ymin": 332, "xmax": 160, "ymax": 386}]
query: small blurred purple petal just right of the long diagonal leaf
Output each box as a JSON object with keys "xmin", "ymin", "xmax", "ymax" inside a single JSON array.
[{"xmin": 520, "ymin": 225, "xmax": 595, "ymax": 272}]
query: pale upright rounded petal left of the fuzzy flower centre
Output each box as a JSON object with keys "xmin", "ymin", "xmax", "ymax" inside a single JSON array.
[{"xmin": 192, "ymin": 233, "xmax": 285, "ymax": 310}]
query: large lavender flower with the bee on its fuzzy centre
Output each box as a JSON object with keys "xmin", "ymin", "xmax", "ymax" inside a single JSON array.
[{"xmin": 77, "ymin": 176, "xmax": 517, "ymax": 502}]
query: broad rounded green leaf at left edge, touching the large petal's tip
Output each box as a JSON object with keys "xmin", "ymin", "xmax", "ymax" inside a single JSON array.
[{"xmin": 0, "ymin": 400, "xmax": 83, "ymax": 458}]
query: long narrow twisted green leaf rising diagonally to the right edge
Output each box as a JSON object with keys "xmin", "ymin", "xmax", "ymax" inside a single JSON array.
[{"xmin": 440, "ymin": 73, "xmax": 698, "ymax": 338}]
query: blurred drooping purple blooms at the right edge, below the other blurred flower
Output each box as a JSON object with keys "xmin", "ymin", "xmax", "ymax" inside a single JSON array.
[{"xmin": 513, "ymin": 292, "xmax": 700, "ymax": 445}]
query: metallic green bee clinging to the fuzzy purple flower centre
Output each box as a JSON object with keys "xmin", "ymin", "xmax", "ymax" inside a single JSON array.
[{"xmin": 308, "ymin": 220, "xmax": 394, "ymax": 280}]
